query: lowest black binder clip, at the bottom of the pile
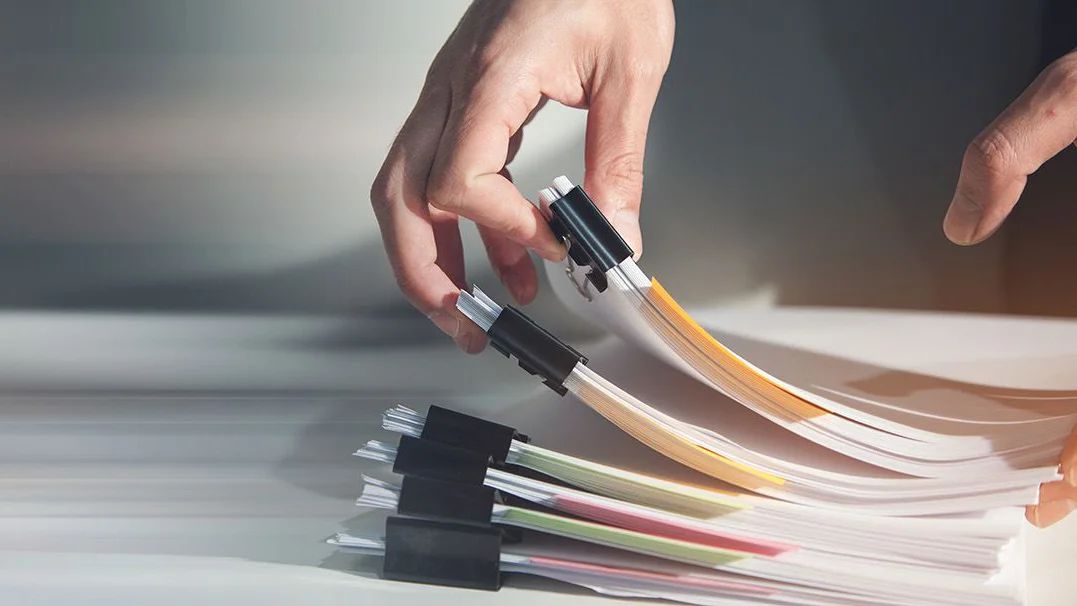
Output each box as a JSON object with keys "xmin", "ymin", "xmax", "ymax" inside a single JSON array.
[{"xmin": 382, "ymin": 516, "xmax": 501, "ymax": 591}]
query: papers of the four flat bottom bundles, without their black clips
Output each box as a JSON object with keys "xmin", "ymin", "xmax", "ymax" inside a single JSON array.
[{"xmin": 331, "ymin": 406, "xmax": 1023, "ymax": 605}]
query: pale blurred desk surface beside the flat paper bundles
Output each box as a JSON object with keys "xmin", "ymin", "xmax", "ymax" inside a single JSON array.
[{"xmin": 0, "ymin": 312, "xmax": 1077, "ymax": 606}]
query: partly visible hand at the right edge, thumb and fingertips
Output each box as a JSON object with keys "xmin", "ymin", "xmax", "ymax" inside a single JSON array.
[{"xmin": 943, "ymin": 53, "xmax": 1077, "ymax": 527}]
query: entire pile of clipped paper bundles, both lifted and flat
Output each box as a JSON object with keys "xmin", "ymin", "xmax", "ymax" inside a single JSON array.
[{"xmin": 331, "ymin": 178, "xmax": 1077, "ymax": 606}]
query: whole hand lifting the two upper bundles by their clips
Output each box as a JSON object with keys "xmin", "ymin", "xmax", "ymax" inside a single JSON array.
[{"xmin": 370, "ymin": 0, "xmax": 673, "ymax": 353}]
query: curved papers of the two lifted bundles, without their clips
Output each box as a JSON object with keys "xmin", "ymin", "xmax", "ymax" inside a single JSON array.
[{"xmin": 459, "ymin": 177, "xmax": 1077, "ymax": 515}]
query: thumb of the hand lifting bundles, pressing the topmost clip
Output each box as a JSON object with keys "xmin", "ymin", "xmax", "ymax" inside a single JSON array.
[{"xmin": 584, "ymin": 70, "xmax": 662, "ymax": 258}]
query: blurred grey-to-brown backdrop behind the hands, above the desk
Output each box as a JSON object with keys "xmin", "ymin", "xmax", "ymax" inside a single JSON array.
[{"xmin": 0, "ymin": 0, "xmax": 1077, "ymax": 335}]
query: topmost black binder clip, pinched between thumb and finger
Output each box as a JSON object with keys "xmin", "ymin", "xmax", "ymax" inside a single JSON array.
[{"xmin": 539, "ymin": 175, "xmax": 633, "ymax": 300}]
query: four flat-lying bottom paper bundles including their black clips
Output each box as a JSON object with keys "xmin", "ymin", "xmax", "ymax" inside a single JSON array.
[{"xmin": 331, "ymin": 406, "xmax": 1023, "ymax": 605}]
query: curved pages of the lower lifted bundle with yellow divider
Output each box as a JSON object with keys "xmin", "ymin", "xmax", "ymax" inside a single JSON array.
[{"xmin": 458, "ymin": 278, "xmax": 1058, "ymax": 515}]
